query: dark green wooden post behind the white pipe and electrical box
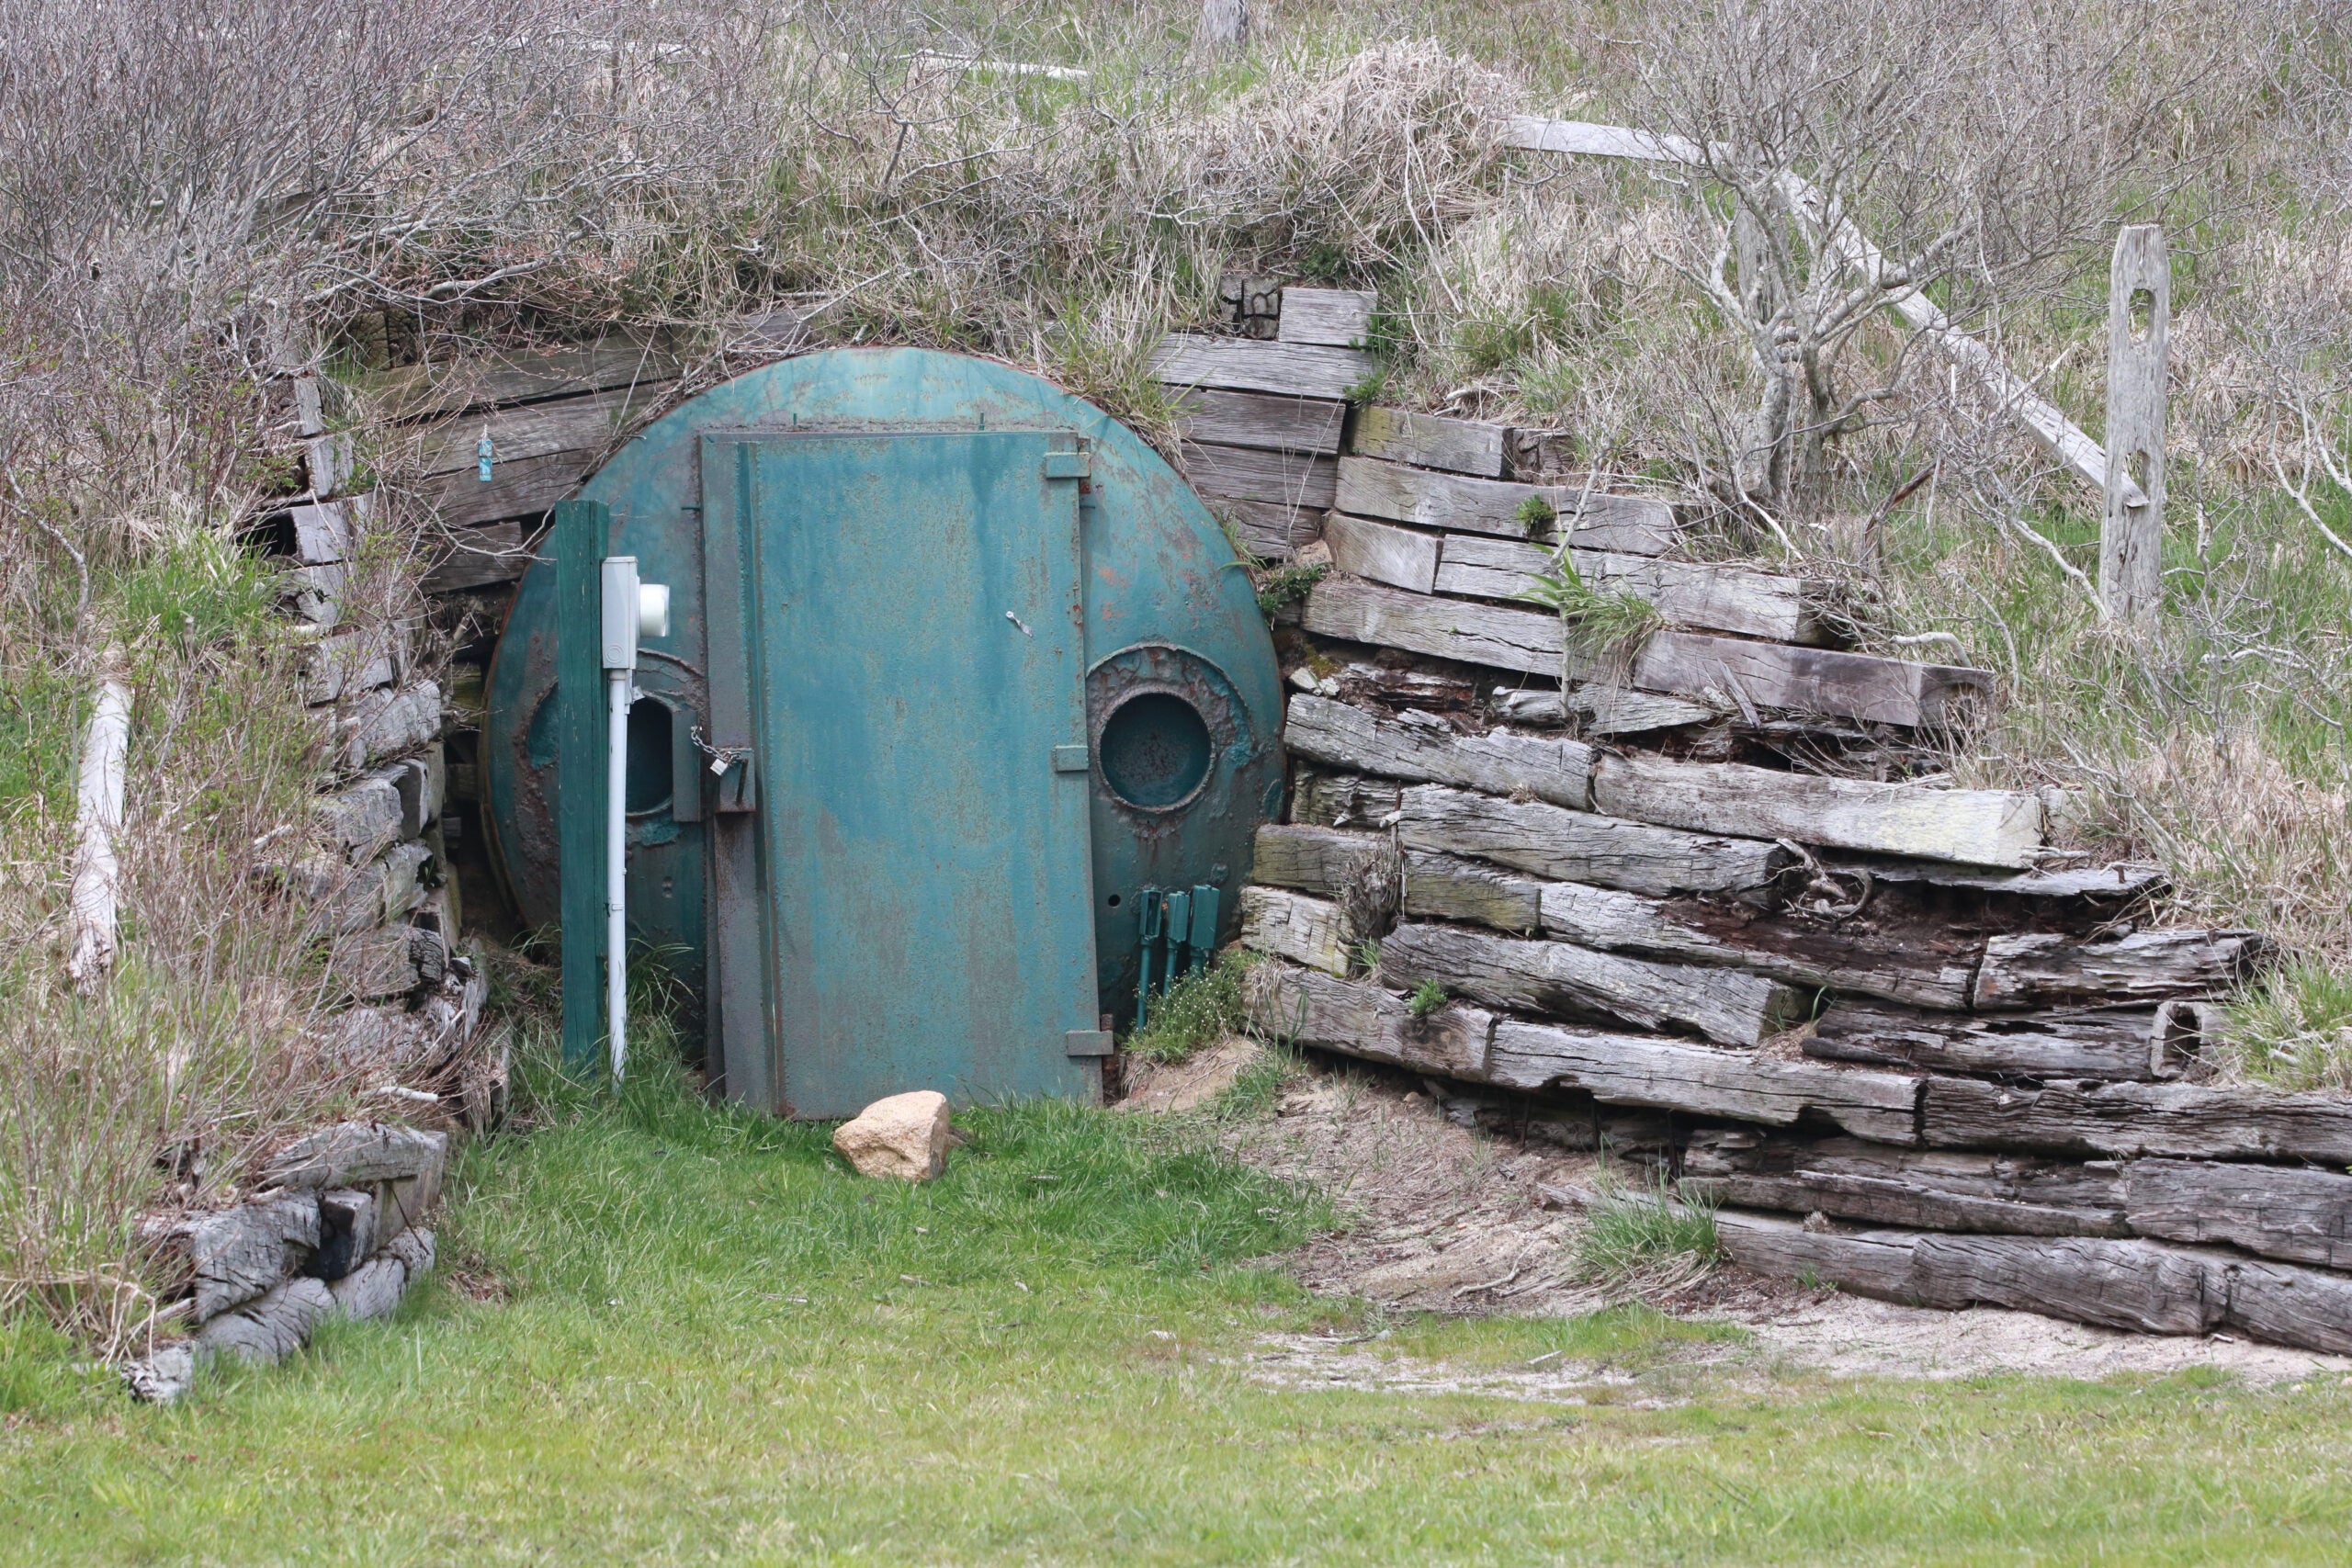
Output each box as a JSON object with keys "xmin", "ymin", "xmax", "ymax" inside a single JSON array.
[{"xmin": 555, "ymin": 501, "xmax": 612, "ymax": 1072}]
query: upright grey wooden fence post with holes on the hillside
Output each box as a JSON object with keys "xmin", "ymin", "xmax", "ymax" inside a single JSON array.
[{"xmin": 2098, "ymin": 223, "xmax": 2173, "ymax": 623}]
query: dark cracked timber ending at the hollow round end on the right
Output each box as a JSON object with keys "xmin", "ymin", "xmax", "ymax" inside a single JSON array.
[{"xmin": 1804, "ymin": 1001, "xmax": 2197, "ymax": 1084}]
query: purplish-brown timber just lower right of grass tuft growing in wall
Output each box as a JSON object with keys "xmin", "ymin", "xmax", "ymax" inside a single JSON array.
[{"xmin": 1627, "ymin": 632, "xmax": 1992, "ymax": 728}]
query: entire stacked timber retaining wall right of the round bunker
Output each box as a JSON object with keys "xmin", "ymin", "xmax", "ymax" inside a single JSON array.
[{"xmin": 1162, "ymin": 291, "xmax": 2352, "ymax": 1352}]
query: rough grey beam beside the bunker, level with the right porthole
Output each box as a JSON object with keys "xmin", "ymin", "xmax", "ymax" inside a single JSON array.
[{"xmin": 1282, "ymin": 694, "xmax": 1592, "ymax": 808}]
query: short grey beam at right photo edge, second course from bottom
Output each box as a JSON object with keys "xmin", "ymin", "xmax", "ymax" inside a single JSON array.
[{"xmin": 2124, "ymin": 1159, "xmax": 2352, "ymax": 1269}]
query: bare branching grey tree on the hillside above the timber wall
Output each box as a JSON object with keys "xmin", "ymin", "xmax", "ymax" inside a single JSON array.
[{"xmin": 1639, "ymin": 0, "xmax": 2197, "ymax": 513}]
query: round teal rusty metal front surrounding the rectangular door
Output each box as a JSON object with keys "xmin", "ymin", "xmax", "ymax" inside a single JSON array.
[{"xmin": 484, "ymin": 350, "xmax": 1282, "ymax": 1107}]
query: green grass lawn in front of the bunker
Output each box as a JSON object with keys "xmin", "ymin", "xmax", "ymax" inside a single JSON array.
[{"xmin": 0, "ymin": 1066, "xmax": 2352, "ymax": 1563}]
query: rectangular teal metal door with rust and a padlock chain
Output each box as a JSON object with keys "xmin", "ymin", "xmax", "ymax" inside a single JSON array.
[{"xmin": 703, "ymin": 430, "xmax": 1099, "ymax": 1117}]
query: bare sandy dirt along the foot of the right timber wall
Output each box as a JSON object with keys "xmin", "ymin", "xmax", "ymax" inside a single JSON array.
[{"xmin": 1185, "ymin": 1065, "xmax": 2352, "ymax": 1401}]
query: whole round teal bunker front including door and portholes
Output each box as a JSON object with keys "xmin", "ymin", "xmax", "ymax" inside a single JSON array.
[{"xmin": 484, "ymin": 350, "xmax": 1282, "ymax": 1117}]
